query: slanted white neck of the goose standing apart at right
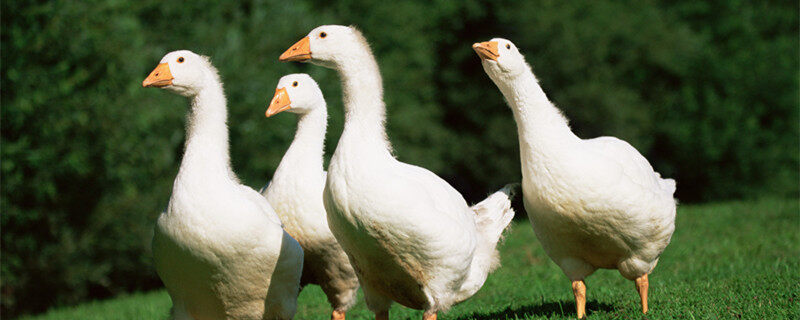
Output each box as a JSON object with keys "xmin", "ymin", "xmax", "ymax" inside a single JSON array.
[{"xmin": 496, "ymin": 69, "xmax": 580, "ymax": 166}]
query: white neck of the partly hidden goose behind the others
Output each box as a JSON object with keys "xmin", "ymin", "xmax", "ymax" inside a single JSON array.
[{"xmin": 272, "ymin": 107, "xmax": 328, "ymax": 182}]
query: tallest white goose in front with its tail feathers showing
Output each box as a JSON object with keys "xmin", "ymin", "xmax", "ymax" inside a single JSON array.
[{"xmin": 279, "ymin": 25, "xmax": 514, "ymax": 320}]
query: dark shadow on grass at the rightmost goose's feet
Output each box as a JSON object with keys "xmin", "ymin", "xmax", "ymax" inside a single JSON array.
[{"xmin": 457, "ymin": 301, "xmax": 614, "ymax": 320}]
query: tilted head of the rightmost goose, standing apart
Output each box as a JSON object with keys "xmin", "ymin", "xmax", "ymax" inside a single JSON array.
[{"xmin": 472, "ymin": 38, "xmax": 529, "ymax": 82}]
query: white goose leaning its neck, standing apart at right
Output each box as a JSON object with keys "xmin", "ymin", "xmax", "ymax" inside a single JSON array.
[{"xmin": 473, "ymin": 38, "xmax": 677, "ymax": 318}]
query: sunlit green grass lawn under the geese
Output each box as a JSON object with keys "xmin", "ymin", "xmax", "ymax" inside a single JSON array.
[{"xmin": 24, "ymin": 200, "xmax": 800, "ymax": 320}]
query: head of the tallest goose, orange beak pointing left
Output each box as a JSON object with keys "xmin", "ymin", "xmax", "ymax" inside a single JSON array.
[{"xmin": 278, "ymin": 25, "xmax": 369, "ymax": 68}]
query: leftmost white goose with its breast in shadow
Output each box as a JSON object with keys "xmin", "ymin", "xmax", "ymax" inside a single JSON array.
[{"xmin": 142, "ymin": 50, "xmax": 303, "ymax": 320}]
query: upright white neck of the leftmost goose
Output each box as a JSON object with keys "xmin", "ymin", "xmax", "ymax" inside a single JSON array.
[{"xmin": 178, "ymin": 75, "xmax": 236, "ymax": 180}]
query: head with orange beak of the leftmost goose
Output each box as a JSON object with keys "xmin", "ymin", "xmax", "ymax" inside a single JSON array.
[{"xmin": 142, "ymin": 50, "xmax": 217, "ymax": 97}]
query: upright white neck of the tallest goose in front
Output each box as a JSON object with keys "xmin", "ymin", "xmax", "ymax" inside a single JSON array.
[{"xmin": 337, "ymin": 49, "xmax": 391, "ymax": 156}]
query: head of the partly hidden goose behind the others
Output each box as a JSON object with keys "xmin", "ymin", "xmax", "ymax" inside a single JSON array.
[{"xmin": 267, "ymin": 73, "xmax": 325, "ymax": 118}]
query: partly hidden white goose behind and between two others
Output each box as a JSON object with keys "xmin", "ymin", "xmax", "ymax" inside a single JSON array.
[{"xmin": 261, "ymin": 74, "xmax": 358, "ymax": 320}]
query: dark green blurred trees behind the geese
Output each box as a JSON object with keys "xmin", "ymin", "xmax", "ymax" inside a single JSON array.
[{"xmin": 0, "ymin": 0, "xmax": 800, "ymax": 316}]
